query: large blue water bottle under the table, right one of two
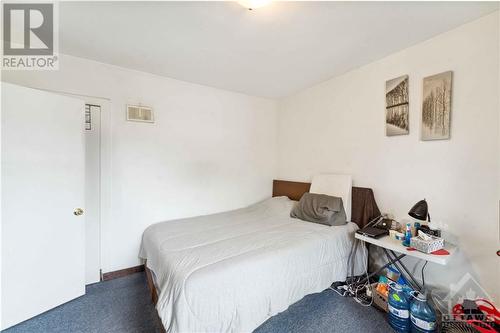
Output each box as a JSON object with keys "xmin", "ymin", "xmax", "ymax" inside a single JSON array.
[{"xmin": 410, "ymin": 291, "xmax": 436, "ymax": 333}]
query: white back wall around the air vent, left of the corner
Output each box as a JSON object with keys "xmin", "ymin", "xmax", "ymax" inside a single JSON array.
[{"xmin": 2, "ymin": 56, "xmax": 276, "ymax": 272}]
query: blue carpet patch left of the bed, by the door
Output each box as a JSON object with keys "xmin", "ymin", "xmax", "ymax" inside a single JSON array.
[{"xmin": 2, "ymin": 273, "xmax": 161, "ymax": 333}]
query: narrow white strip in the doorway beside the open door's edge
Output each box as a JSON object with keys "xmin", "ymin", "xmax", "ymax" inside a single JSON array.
[{"xmin": 85, "ymin": 104, "xmax": 101, "ymax": 284}]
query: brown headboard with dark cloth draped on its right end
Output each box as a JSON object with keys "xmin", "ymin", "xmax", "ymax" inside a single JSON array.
[{"xmin": 273, "ymin": 180, "xmax": 380, "ymax": 228}]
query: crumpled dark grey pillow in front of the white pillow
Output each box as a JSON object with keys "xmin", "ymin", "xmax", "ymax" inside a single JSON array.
[{"xmin": 290, "ymin": 193, "xmax": 347, "ymax": 226}]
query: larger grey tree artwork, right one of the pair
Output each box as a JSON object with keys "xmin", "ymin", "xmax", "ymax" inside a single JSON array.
[{"xmin": 422, "ymin": 71, "xmax": 452, "ymax": 141}]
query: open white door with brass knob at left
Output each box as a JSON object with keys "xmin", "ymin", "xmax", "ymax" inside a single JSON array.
[{"xmin": 1, "ymin": 83, "xmax": 85, "ymax": 329}]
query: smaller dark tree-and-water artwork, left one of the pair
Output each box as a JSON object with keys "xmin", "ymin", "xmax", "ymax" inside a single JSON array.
[{"xmin": 385, "ymin": 75, "xmax": 410, "ymax": 136}]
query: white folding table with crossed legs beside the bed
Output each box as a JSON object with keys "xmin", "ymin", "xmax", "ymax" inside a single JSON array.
[{"xmin": 355, "ymin": 233, "xmax": 456, "ymax": 291}]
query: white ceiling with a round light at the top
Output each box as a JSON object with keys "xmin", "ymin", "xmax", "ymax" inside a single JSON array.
[{"xmin": 59, "ymin": 1, "xmax": 498, "ymax": 98}]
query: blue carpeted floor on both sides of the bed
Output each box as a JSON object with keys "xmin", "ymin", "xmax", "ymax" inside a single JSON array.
[{"xmin": 2, "ymin": 273, "xmax": 392, "ymax": 333}]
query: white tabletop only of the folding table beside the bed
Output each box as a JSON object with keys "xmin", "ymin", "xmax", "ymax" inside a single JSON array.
[{"xmin": 355, "ymin": 233, "xmax": 457, "ymax": 265}]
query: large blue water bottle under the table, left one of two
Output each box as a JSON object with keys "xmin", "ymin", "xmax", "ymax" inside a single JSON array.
[{"xmin": 388, "ymin": 282, "xmax": 410, "ymax": 333}]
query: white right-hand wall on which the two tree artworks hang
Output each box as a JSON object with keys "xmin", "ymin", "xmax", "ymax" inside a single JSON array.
[{"xmin": 277, "ymin": 12, "xmax": 500, "ymax": 300}]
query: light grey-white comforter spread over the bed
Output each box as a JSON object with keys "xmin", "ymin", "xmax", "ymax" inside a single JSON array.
[{"xmin": 140, "ymin": 197, "xmax": 365, "ymax": 332}]
